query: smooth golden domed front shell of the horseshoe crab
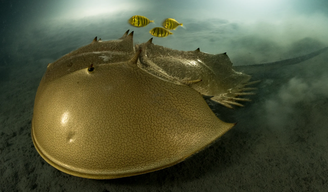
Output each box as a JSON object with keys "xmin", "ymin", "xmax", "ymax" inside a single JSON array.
[{"xmin": 31, "ymin": 30, "xmax": 234, "ymax": 179}]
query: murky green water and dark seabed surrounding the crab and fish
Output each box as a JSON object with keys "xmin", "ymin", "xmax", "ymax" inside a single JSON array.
[{"xmin": 0, "ymin": 0, "xmax": 328, "ymax": 191}]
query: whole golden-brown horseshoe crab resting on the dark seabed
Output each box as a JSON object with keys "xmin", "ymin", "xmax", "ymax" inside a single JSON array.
[{"xmin": 31, "ymin": 31, "xmax": 322, "ymax": 179}]
